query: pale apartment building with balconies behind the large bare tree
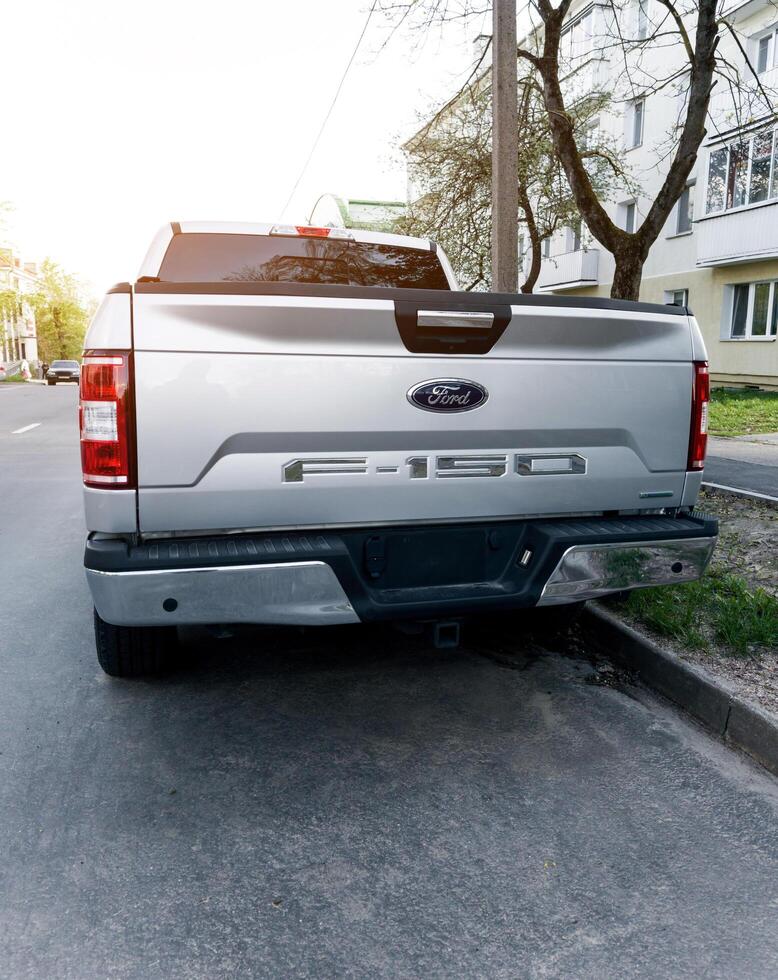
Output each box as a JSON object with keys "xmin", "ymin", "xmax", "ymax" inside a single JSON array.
[{"xmin": 536, "ymin": 0, "xmax": 778, "ymax": 389}]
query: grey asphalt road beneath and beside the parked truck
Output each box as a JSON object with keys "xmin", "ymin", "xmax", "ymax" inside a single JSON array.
[{"xmin": 0, "ymin": 386, "xmax": 778, "ymax": 980}]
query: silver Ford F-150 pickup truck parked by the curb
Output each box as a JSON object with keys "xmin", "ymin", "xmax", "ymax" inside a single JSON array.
[{"xmin": 80, "ymin": 223, "xmax": 717, "ymax": 676}]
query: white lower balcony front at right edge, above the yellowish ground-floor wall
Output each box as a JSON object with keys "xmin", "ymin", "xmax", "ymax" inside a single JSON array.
[{"xmin": 694, "ymin": 200, "xmax": 778, "ymax": 266}]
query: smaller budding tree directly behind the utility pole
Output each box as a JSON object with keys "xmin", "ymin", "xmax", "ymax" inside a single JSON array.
[{"xmin": 397, "ymin": 63, "xmax": 628, "ymax": 293}]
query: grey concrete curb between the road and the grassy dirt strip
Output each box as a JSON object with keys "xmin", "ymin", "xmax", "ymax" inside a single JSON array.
[{"xmin": 581, "ymin": 606, "xmax": 778, "ymax": 776}]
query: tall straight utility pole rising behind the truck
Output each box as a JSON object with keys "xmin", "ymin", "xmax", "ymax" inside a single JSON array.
[{"xmin": 492, "ymin": 0, "xmax": 519, "ymax": 293}]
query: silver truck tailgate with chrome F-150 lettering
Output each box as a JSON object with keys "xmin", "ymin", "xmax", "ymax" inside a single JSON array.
[{"xmin": 134, "ymin": 284, "xmax": 693, "ymax": 532}]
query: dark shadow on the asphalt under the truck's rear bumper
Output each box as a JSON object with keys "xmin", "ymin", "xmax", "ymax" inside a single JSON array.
[{"xmin": 101, "ymin": 621, "xmax": 618, "ymax": 779}]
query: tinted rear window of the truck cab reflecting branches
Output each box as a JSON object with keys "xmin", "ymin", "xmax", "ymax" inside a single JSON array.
[{"xmin": 159, "ymin": 232, "xmax": 450, "ymax": 289}]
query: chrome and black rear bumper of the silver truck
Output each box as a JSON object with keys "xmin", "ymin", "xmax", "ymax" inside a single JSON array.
[{"xmin": 84, "ymin": 515, "xmax": 718, "ymax": 626}]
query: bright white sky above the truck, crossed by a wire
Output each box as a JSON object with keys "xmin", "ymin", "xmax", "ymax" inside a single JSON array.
[{"xmin": 0, "ymin": 0, "xmax": 478, "ymax": 292}]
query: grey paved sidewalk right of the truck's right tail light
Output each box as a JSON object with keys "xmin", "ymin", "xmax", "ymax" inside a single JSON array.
[{"xmin": 703, "ymin": 432, "xmax": 778, "ymax": 497}]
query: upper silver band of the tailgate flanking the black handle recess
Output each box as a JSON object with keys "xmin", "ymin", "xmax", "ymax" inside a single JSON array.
[{"xmin": 133, "ymin": 290, "xmax": 699, "ymax": 364}]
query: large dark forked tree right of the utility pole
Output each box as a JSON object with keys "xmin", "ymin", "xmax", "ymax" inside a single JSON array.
[{"xmin": 382, "ymin": 0, "xmax": 773, "ymax": 299}]
